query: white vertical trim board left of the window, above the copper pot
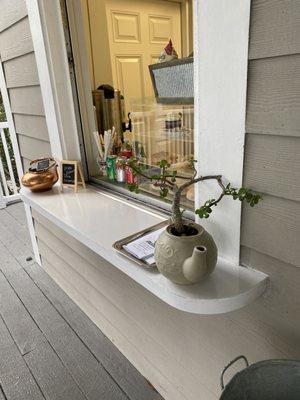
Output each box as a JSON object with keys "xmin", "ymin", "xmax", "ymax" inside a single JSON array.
[{"xmin": 26, "ymin": 0, "xmax": 80, "ymax": 160}]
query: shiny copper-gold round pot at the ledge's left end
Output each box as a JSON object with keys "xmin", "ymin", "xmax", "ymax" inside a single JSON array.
[{"xmin": 22, "ymin": 158, "xmax": 58, "ymax": 192}]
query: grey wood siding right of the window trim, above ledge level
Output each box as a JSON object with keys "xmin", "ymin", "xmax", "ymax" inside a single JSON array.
[{"xmin": 241, "ymin": 0, "xmax": 300, "ymax": 266}]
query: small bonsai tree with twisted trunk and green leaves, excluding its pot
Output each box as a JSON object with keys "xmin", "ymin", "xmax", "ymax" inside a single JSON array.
[{"xmin": 127, "ymin": 158, "xmax": 262, "ymax": 236}]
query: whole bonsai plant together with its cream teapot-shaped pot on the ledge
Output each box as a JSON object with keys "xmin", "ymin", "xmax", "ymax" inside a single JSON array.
[{"xmin": 128, "ymin": 158, "xmax": 262, "ymax": 285}]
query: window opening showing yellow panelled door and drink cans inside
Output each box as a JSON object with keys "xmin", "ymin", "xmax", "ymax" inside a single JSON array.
[{"xmin": 65, "ymin": 0, "xmax": 194, "ymax": 210}]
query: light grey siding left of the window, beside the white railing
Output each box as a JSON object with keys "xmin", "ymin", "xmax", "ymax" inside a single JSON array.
[{"xmin": 0, "ymin": 0, "xmax": 51, "ymax": 170}]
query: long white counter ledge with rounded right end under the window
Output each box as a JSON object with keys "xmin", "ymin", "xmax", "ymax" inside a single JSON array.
[{"xmin": 21, "ymin": 187, "xmax": 268, "ymax": 314}]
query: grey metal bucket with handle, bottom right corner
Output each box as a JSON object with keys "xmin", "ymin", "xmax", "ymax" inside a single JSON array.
[{"xmin": 220, "ymin": 356, "xmax": 300, "ymax": 400}]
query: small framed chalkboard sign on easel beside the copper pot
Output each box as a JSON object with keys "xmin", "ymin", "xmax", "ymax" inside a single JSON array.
[{"xmin": 60, "ymin": 160, "xmax": 85, "ymax": 192}]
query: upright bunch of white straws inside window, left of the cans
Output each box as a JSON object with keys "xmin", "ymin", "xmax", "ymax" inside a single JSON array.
[{"xmin": 93, "ymin": 127, "xmax": 116, "ymax": 176}]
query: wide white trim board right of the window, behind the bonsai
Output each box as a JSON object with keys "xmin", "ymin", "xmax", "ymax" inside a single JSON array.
[{"xmin": 194, "ymin": 0, "xmax": 250, "ymax": 264}]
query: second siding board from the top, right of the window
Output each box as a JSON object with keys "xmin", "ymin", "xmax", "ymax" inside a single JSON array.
[{"xmin": 246, "ymin": 54, "xmax": 300, "ymax": 137}]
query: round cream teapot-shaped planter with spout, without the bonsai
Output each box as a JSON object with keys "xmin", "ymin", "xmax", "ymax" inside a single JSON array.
[{"xmin": 155, "ymin": 223, "xmax": 218, "ymax": 285}]
